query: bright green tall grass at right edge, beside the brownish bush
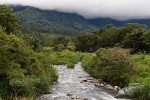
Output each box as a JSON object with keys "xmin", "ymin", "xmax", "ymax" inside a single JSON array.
[{"xmin": 131, "ymin": 53, "xmax": 150, "ymax": 100}]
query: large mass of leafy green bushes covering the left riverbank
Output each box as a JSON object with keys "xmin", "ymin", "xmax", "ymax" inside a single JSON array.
[{"xmin": 0, "ymin": 27, "xmax": 57, "ymax": 99}]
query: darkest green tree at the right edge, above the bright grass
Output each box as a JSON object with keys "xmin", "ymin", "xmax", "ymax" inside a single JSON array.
[{"xmin": 123, "ymin": 29, "xmax": 150, "ymax": 52}]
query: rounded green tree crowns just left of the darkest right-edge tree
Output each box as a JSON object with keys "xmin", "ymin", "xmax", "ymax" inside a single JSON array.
[{"xmin": 93, "ymin": 24, "xmax": 126, "ymax": 48}]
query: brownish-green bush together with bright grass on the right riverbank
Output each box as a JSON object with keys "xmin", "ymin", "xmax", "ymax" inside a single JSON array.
[{"xmin": 82, "ymin": 48, "xmax": 150, "ymax": 100}]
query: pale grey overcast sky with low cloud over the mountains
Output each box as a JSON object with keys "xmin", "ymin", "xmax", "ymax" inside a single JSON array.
[{"xmin": 0, "ymin": 0, "xmax": 150, "ymax": 20}]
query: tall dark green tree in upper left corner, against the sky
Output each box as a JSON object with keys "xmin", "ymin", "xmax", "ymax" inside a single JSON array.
[{"xmin": 0, "ymin": 5, "xmax": 21, "ymax": 34}]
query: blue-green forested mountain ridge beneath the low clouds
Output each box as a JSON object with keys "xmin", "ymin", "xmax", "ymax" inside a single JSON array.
[{"xmin": 10, "ymin": 5, "xmax": 150, "ymax": 35}]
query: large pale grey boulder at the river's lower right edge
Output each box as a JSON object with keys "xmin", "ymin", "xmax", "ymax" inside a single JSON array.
[{"xmin": 116, "ymin": 83, "xmax": 141, "ymax": 99}]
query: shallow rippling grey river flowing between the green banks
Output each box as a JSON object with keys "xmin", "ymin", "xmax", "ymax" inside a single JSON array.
[{"xmin": 36, "ymin": 63, "xmax": 125, "ymax": 100}]
